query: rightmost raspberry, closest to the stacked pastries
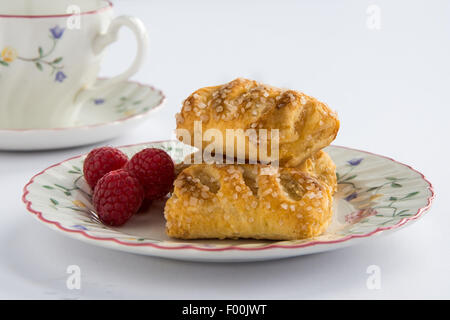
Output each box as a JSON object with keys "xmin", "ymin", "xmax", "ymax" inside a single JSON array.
[{"xmin": 125, "ymin": 148, "xmax": 175, "ymax": 200}]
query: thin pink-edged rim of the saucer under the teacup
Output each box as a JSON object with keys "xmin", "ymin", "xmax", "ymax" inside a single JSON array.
[{"xmin": 0, "ymin": 77, "xmax": 167, "ymax": 134}]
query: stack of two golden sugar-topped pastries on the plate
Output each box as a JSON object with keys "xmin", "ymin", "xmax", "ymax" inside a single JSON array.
[{"xmin": 165, "ymin": 79, "xmax": 339, "ymax": 240}]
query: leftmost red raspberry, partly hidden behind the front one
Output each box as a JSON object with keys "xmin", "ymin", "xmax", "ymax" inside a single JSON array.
[{"xmin": 83, "ymin": 147, "xmax": 128, "ymax": 189}]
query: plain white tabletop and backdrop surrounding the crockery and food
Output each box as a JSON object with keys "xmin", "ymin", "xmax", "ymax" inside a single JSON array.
[{"xmin": 0, "ymin": 0, "xmax": 450, "ymax": 299}]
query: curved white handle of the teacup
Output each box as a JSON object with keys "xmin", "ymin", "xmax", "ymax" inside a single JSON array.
[{"xmin": 75, "ymin": 16, "xmax": 148, "ymax": 102}]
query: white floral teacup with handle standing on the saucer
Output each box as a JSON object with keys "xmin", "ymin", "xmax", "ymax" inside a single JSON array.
[{"xmin": 0, "ymin": 0, "xmax": 148, "ymax": 129}]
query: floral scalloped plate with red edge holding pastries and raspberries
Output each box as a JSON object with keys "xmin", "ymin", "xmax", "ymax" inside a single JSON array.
[{"xmin": 23, "ymin": 141, "xmax": 434, "ymax": 262}]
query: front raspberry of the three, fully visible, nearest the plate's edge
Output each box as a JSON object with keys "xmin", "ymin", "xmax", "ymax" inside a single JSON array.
[{"xmin": 92, "ymin": 169, "xmax": 144, "ymax": 226}]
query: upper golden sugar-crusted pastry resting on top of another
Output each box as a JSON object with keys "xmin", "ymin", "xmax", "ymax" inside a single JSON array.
[{"xmin": 176, "ymin": 78, "xmax": 339, "ymax": 167}]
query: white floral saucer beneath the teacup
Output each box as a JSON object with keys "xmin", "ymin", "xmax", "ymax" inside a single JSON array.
[{"xmin": 0, "ymin": 79, "xmax": 165, "ymax": 151}]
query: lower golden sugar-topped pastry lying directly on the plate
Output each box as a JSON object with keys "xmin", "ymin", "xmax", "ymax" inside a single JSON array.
[{"xmin": 164, "ymin": 164, "xmax": 332, "ymax": 240}]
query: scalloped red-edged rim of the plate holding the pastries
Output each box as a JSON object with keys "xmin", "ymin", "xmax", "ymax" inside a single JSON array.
[{"xmin": 22, "ymin": 140, "xmax": 435, "ymax": 251}]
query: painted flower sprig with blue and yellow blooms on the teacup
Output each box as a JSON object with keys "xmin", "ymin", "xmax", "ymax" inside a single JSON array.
[{"xmin": 0, "ymin": 25, "xmax": 67, "ymax": 82}]
